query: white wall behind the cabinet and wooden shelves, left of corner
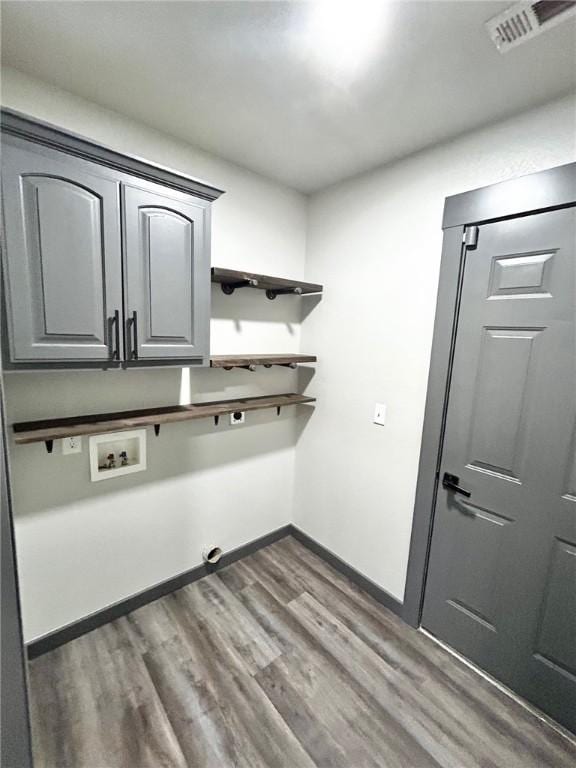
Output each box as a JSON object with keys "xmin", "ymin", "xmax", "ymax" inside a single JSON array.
[{"xmin": 2, "ymin": 69, "xmax": 306, "ymax": 640}]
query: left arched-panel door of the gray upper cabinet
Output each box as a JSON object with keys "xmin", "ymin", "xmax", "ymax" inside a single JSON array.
[{"xmin": 2, "ymin": 140, "xmax": 122, "ymax": 363}]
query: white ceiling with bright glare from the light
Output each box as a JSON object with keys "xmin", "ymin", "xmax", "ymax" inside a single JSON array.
[{"xmin": 2, "ymin": 0, "xmax": 576, "ymax": 192}]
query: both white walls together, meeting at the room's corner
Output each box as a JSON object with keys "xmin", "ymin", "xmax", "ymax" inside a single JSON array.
[{"xmin": 2, "ymin": 70, "xmax": 576, "ymax": 640}]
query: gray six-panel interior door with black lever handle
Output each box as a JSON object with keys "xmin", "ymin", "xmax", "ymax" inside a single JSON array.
[{"xmin": 422, "ymin": 208, "xmax": 576, "ymax": 730}]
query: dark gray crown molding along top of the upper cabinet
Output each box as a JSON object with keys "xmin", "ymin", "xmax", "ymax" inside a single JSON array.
[{"xmin": 0, "ymin": 109, "xmax": 224, "ymax": 202}]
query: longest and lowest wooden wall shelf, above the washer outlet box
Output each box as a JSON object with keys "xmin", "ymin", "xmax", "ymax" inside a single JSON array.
[{"xmin": 12, "ymin": 393, "xmax": 316, "ymax": 453}]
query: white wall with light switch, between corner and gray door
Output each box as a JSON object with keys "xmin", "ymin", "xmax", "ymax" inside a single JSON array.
[{"xmin": 294, "ymin": 98, "xmax": 576, "ymax": 600}]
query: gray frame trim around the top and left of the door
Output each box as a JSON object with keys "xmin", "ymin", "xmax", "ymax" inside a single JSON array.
[{"xmin": 402, "ymin": 162, "xmax": 576, "ymax": 627}]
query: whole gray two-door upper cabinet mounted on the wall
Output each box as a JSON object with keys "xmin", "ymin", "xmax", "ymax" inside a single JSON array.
[{"xmin": 2, "ymin": 112, "xmax": 221, "ymax": 369}]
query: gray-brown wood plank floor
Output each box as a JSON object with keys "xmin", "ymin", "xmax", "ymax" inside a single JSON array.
[{"xmin": 30, "ymin": 537, "xmax": 576, "ymax": 768}]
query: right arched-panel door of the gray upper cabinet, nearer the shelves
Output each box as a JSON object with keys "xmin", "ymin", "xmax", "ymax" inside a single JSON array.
[{"xmin": 123, "ymin": 184, "xmax": 210, "ymax": 363}]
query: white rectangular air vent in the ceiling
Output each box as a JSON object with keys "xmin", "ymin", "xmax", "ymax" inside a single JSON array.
[{"xmin": 486, "ymin": 0, "xmax": 576, "ymax": 53}]
